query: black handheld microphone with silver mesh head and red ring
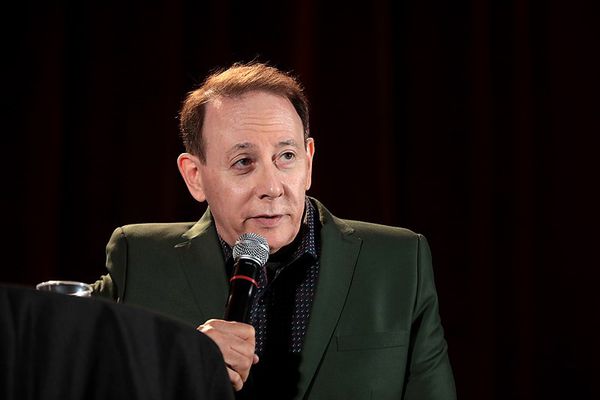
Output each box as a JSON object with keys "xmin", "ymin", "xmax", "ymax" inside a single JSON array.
[{"xmin": 224, "ymin": 233, "xmax": 269, "ymax": 323}]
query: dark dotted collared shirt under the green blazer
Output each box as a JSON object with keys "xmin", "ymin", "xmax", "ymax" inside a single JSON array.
[{"xmin": 221, "ymin": 198, "xmax": 320, "ymax": 398}]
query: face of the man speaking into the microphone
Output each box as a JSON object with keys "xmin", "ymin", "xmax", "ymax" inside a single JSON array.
[{"xmin": 193, "ymin": 91, "xmax": 314, "ymax": 253}]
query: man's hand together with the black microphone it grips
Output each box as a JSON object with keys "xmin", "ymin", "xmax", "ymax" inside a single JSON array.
[{"xmin": 198, "ymin": 233, "xmax": 269, "ymax": 390}]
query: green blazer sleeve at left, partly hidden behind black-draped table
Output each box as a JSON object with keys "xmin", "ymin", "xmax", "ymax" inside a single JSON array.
[{"xmin": 92, "ymin": 227, "xmax": 127, "ymax": 301}]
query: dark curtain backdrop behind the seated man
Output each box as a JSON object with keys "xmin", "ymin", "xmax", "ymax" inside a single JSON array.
[{"xmin": 0, "ymin": 0, "xmax": 600, "ymax": 399}]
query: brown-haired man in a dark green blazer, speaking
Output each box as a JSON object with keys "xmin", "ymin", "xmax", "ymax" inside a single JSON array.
[{"xmin": 95, "ymin": 63, "xmax": 455, "ymax": 399}]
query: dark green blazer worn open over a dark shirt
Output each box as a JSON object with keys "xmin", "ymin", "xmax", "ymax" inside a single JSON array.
[{"xmin": 94, "ymin": 199, "xmax": 456, "ymax": 399}]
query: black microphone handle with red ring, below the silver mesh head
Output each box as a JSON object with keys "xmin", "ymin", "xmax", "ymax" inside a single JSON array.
[{"xmin": 224, "ymin": 258, "xmax": 260, "ymax": 323}]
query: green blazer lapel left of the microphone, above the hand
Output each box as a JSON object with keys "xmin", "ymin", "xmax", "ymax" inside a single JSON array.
[{"xmin": 175, "ymin": 209, "xmax": 228, "ymax": 323}]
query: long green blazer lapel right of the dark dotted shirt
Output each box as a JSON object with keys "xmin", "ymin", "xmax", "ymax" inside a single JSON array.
[{"xmin": 297, "ymin": 199, "xmax": 362, "ymax": 399}]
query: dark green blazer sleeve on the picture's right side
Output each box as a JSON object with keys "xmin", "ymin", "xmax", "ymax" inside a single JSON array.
[{"xmin": 404, "ymin": 235, "xmax": 456, "ymax": 400}]
